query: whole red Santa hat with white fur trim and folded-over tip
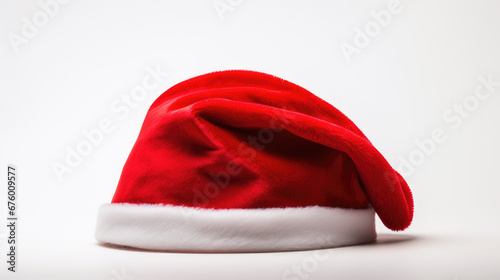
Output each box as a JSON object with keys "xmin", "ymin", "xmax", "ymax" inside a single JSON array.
[{"xmin": 96, "ymin": 71, "xmax": 413, "ymax": 252}]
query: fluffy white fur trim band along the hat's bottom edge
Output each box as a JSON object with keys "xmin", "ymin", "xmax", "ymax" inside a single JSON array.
[{"xmin": 96, "ymin": 203, "xmax": 376, "ymax": 252}]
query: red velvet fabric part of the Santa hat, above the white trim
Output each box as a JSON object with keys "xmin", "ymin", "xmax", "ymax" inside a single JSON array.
[{"xmin": 112, "ymin": 70, "xmax": 413, "ymax": 230}]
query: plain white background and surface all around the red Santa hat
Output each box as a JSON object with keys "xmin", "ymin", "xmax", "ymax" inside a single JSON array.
[{"xmin": 0, "ymin": 0, "xmax": 500, "ymax": 280}]
